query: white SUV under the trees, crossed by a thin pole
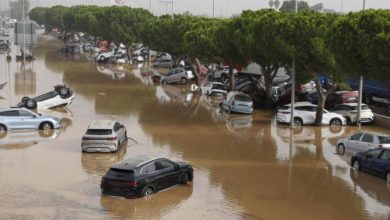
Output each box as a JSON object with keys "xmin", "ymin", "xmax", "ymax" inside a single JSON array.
[{"xmin": 276, "ymin": 102, "xmax": 347, "ymax": 126}]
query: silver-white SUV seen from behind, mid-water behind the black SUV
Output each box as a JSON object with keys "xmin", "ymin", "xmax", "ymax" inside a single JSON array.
[{"xmin": 81, "ymin": 120, "xmax": 127, "ymax": 152}]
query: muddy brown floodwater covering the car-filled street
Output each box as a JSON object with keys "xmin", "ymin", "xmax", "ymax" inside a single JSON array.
[{"xmin": 0, "ymin": 35, "xmax": 390, "ymax": 220}]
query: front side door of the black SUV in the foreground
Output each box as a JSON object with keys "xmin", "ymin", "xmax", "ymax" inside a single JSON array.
[{"xmin": 155, "ymin": 159, "xmax": 180, "ymax": 188}]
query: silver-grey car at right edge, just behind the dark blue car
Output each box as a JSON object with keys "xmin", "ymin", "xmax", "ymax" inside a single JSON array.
[{"xmin": 337, "ymin": 132, "xmax": 390, "ymax": 154}]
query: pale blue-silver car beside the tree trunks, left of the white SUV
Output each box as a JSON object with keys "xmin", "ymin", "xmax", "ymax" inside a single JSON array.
[{"xmin": 222, "ymin": 91, "xmax": 253, "ymax": 114}]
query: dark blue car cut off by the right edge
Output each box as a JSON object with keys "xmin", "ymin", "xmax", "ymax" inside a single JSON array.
[{"xmin": 351, "ymin": 148, "xmax": 390, "ymax": 183}]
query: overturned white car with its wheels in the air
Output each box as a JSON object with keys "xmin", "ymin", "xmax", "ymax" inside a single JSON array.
[{"xmin": 17, "ymin": 85, "xmax": 74, "ymax": 109}]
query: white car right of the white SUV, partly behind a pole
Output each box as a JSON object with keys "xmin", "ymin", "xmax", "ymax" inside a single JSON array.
[{"xmin": 333, "ymin": 102, "xmax": 374, "ymax": 124}]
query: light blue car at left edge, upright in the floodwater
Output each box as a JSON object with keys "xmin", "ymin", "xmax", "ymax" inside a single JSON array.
[{"xmin": 0, "ymin": 108, "xmax": 61, "ymax": 133}]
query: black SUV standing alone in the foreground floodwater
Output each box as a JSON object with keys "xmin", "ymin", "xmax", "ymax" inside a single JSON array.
[{"xmin": 100, "ymin": 156, "xmax": 193, "ymax": 198}]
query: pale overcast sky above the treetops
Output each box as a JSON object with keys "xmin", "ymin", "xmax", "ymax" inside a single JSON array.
[{"xmin": 0, "ymin": 0, "xmax": 390, "ymax": 17}]
